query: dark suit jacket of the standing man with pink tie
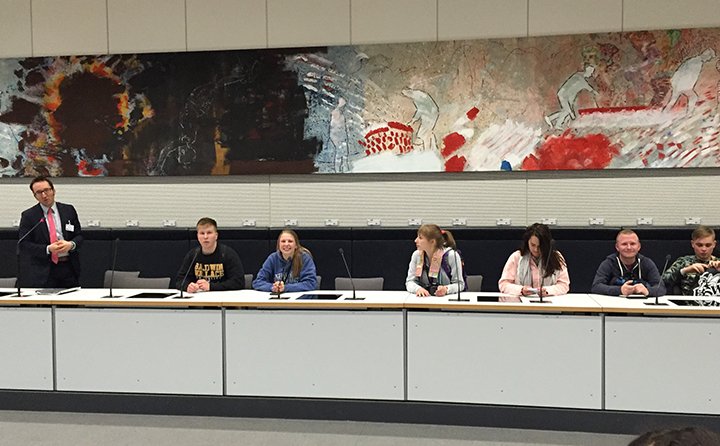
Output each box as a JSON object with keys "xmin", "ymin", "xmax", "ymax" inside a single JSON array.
[{"xmin": 18, "ymin": 202, "xmax": 83, "ymax": 288}]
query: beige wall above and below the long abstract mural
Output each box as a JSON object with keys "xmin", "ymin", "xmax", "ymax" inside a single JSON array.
[{"xmin": 0, "ymin": 0, "xmax": 720, "ymax": 227}]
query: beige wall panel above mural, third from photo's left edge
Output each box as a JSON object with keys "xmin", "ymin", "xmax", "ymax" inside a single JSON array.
[{"xmin": 107, "ymin": 0, "xmax": 186, "ymax": 54}]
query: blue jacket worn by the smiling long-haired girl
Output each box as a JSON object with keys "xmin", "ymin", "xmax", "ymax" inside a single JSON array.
[{"xmin": 253, "ymin": 251, "xmax": 317, "ymax": 293}]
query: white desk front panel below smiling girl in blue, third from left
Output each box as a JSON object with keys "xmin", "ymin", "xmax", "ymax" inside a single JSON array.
[{"xmin": 226, "ymin": 310, "xmax": 404, "ymax": 400}]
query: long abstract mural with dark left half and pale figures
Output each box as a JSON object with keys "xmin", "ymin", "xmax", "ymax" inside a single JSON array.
[{"xmin": 0, "ymin": 29, "xmax": 720, "ymax": 177}]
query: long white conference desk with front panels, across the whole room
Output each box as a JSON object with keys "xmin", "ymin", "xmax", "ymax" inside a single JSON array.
[{"xmin": 0, "ymin": 289, "xmax": 720, "ymax": 414}]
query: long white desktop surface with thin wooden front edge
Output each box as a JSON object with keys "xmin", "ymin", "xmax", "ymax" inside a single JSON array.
[{"xmin": 0, "ymin": 288, "xmax": 720, "ymax": 317}]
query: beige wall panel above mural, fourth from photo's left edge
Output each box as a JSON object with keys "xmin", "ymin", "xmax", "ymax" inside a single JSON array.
[{"xmin": 186, "ymin": 0, "xmax": 267, "ymax": 51}]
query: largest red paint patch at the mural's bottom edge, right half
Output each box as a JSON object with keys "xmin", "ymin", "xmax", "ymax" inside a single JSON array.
[{"xmin": 522, "ymin": 131, "xmax": 620, "ymax": 170}]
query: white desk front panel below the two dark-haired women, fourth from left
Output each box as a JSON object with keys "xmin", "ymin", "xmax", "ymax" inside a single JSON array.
[{"xmin": 408, "ymin": 312, "xmax": 602, "ymax": 409}]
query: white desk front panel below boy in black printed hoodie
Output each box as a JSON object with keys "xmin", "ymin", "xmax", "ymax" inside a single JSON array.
[{"xmin": 55, "ymin": 308, "xmax": 223, "ymax": 395}]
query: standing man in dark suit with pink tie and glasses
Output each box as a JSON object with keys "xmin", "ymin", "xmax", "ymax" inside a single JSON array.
[{"xmin": 18, "ymin": 176, "xmax": 83, "ymax": 288}]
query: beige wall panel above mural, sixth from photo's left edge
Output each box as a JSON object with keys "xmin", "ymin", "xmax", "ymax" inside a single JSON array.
[{"xmin": 351, "ymin": 0, "xmax": 437, "ymax": 44}]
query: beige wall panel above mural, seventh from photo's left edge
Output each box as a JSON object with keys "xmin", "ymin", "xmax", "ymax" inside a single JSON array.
[{"xmin": 438, "ymin": 0, "xmax": 528, "ymax": 40}]
